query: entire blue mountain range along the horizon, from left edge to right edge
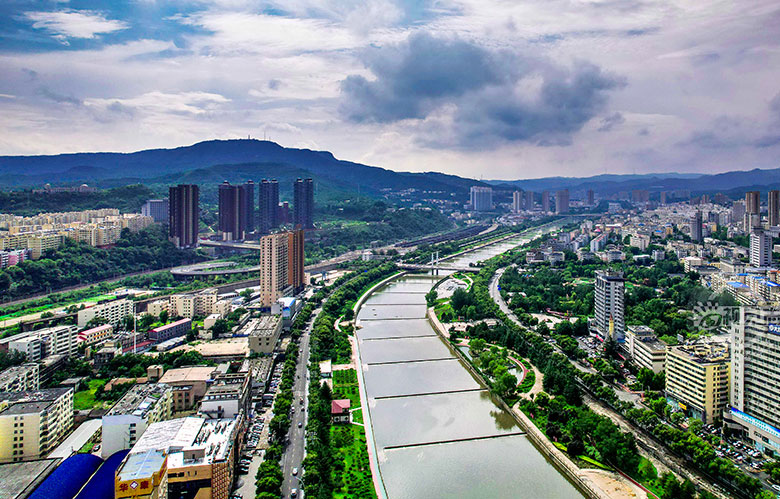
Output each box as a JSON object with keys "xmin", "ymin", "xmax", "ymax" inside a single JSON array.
[{"xmin": 0, "ymin": 139, "xmax": 780, "ymax": 199}]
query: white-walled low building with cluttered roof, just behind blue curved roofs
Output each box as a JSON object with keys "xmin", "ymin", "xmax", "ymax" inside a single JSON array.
[{"xmin": 100, "ymin": 383, "xmax": 173, "ymax": 458}]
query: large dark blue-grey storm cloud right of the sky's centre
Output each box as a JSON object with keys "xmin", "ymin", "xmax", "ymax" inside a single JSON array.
[{"xmin": 341, "ymin": 34, "xmax": 625, "ymax": 149}]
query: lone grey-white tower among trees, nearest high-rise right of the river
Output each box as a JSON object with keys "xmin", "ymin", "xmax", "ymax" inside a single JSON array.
[{"xmin": 595, "ymin": 270, "xmax": 626, "ymax": 342}]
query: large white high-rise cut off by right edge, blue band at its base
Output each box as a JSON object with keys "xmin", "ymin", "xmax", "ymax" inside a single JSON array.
[{"xmin": 725, "ymin": 307, "xmax": 780, "ymax": 454}]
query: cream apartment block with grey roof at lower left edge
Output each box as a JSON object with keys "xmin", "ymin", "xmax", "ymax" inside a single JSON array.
[{"xmin": 0, "ymin": 388, "xmax": 73, "ymax": 463}]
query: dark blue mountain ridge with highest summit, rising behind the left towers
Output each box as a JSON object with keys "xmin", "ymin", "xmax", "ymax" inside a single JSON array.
[{"xmin": 0, "ymin": 139, "xmax": 481, "ymax": 198}]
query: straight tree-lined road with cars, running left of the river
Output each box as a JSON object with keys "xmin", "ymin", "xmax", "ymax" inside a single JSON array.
[{"xmin": 281, "ymin": 308, "xmax": 321, "ymax": 497}]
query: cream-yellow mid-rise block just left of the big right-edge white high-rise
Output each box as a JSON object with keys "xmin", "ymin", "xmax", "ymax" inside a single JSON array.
[{"xmin": 666, "ymin": 343, "xmax": 730, "ymax": 423}]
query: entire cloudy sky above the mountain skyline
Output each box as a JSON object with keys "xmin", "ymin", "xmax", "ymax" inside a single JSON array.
[{"xmin": 0, "ymin": 0, "xmax": 780, "ymax": 179}]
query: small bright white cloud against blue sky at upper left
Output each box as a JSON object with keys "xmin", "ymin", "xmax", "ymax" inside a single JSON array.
[{"xmin": 25, "ymin": 10, "xmax": 130, "ymax": 40}]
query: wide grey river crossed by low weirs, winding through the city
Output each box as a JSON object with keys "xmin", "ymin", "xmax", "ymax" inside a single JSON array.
[{"xmin": 357, "ymin": 226, "xmax": 582, "ymax": 499}]
